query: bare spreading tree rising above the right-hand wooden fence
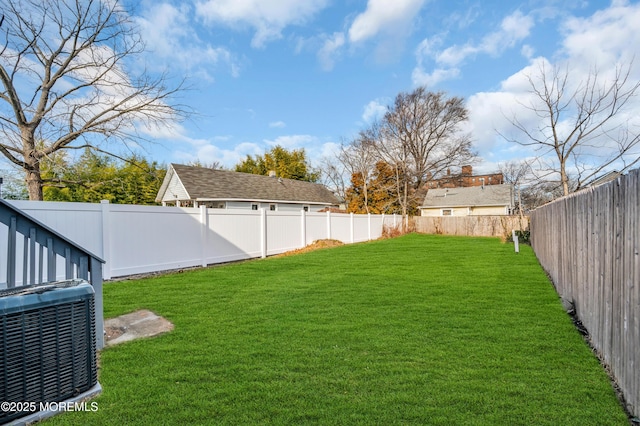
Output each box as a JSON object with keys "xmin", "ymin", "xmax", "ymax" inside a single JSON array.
[{"xmin": 503, "ymin": 63, "xmax": 640, "ymax": 195}]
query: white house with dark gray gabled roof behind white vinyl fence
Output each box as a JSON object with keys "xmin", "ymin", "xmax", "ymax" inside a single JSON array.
[{"xmin": 156, "ymin": 164, "xmax": 340, "ymax": 212}]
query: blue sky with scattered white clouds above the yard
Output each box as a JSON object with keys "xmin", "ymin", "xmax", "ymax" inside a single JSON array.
[{"xmin": 5, "ymin": 0, "xmax": 640, "ymax": 181}]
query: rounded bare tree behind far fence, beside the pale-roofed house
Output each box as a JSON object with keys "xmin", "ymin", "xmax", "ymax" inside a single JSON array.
[{"xmin": 376, "ymin": 87, "xmax": 475, "ymax": 215}]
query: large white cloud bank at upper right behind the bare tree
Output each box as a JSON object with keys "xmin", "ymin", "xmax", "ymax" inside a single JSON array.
[{"xmin": 467, "ymin": 2, "xmax": 640, "ymax": 168}]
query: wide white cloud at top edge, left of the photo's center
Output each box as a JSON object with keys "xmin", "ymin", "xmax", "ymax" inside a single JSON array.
[{"xmin": 196, "ymin": 0, "xmax": 327, "ymax": 48}]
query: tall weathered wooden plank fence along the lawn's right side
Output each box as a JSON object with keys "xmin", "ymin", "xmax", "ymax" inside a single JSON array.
[{"xmin": 531, "ymin": 170, "xmax": 640, "ymax": 416}]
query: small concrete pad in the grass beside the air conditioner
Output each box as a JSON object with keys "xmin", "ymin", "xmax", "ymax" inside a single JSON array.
[{"xmin": 104, "ymin": 309, "xmax": 173, "ymax": 346}]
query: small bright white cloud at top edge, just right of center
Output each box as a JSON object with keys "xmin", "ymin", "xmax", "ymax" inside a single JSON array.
[{"xmin": 349, "ymin": 0, "xmax": 425, "ymax": 43}]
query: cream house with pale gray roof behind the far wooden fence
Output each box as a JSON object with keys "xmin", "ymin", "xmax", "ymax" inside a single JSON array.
[{"xmin": 419, "ymin": 185, "xmax": 514, "ymax": 216}]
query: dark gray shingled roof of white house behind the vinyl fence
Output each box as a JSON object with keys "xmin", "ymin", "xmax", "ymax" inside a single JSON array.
[{"xmin": 158, "ymin": 164, "xmax": 340, "ymax": 205}]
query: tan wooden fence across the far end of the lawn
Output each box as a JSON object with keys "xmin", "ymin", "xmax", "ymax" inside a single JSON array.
[{"xmin": 411, "ymin": 216, "xmax": 529, "ymax": 238}]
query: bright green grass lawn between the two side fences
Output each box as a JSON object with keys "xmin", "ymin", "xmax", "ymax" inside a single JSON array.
[{"xmin": 50, "ymin": 234, "xmax": 628, "ymax": 425}]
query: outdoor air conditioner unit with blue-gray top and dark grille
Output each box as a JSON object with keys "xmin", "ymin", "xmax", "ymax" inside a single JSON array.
[{"xmin": 0, "ymin": 280, "xmax": 99, "ymax": 424}]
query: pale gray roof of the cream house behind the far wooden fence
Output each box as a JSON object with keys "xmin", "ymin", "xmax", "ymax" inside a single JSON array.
[{"xmin": 421, "ymin": 185, "xmax": 513, "ymax": 207}]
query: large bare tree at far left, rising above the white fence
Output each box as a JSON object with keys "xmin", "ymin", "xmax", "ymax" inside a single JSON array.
[{"xmin": 0, "ymin": 0, "xmax": 186, "ymax": 200}]
